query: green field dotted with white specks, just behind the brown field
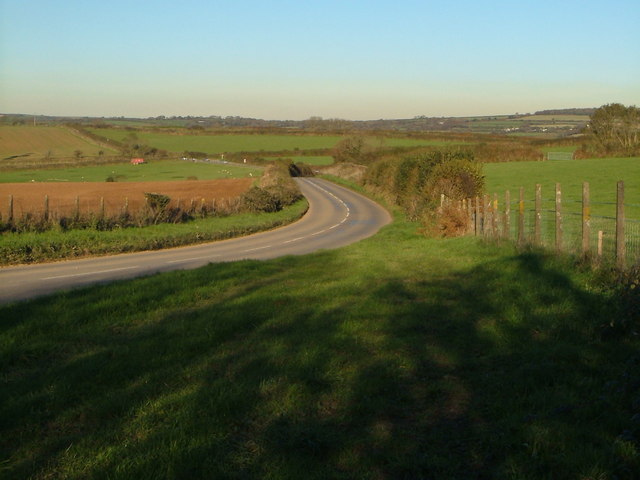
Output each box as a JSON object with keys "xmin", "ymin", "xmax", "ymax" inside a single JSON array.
[{"xmin": 0, "ymin": 160, "xmax": 262, "ymax": 183}]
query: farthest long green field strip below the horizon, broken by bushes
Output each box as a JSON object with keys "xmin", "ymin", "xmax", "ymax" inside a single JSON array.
[{"xmin": 90, "ymin": 128, "xmax": 464, "ymax": 154}]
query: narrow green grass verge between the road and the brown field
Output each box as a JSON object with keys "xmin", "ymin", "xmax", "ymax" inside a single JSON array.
[{"xmin": 0, "ymin": 201, "xmax": 308, "ymax": 265}]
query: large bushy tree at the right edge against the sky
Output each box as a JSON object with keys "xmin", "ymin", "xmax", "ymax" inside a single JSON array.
[{"xmin": 588, "ymin": 103, "xmax": 640, "ymax": 155}]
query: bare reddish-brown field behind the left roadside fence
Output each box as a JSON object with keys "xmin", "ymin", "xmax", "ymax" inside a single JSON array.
[{"xmin": 0, "ymin": 178, "xmax": 253, "ymax": 219}]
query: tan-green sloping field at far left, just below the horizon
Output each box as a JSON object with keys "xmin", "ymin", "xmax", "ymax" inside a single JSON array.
[{"xmin": 0, "ymin": 125, "xmax": 114, "ymax": 160}]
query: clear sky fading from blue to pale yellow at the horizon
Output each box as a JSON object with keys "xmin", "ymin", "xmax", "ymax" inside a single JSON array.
[{"xmin": 0, "ymin": 0, "xmax": 640, "ymax": 120}]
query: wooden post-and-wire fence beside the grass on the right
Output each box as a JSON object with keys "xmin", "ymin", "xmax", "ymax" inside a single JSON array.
[{"xmin": 460, "ymin": 181, "xmax": 640, "ymax": 268}]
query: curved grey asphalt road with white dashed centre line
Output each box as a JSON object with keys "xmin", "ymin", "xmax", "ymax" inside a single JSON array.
[{"xmin": 0, "ymin": 178, "xmax": 391, "ymax": 302}]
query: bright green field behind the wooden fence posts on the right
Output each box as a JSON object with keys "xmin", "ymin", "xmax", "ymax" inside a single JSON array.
[{"xmin": 483, "ymin": 158, "xmax": 640, "ymax": 219}]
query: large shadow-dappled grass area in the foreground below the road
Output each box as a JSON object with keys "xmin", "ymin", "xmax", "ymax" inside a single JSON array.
[{"xmin": 0, "ymin": 211, "xmax": 640, "ymax": 480}]
